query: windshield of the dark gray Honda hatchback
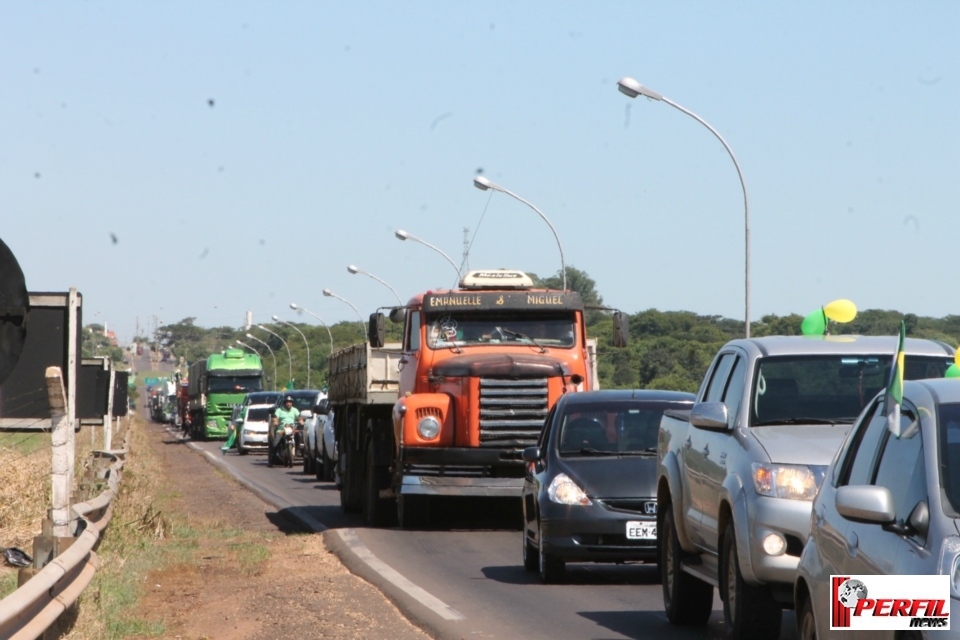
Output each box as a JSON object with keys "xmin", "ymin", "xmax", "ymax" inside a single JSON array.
[{"xmin": 558, "ymin": 400, "xmax": 692, "ymax": 456}]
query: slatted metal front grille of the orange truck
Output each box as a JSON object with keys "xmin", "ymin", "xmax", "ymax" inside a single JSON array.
[{"xmin": 480, "ymin": 378, "xmax": 547, "ymax": 447}]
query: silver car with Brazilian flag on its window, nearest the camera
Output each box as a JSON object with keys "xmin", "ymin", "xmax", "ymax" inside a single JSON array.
[{"xmin": 794, "ymin": 378, "xmax": 960, "ymax": 640}]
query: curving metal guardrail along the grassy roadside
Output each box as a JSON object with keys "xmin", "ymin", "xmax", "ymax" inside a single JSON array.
[{"xmin": 0, "ymin": 442, "xmax": 126, "ymax": 640}]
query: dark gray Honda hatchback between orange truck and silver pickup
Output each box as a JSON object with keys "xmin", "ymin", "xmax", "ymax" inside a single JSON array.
[{"xmin": 522, "ymin": 390, "xmax": 694, "ymax": 583}]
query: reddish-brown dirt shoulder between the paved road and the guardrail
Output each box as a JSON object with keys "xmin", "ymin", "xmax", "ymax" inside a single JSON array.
[{"xmin": 138, "ymin": 424, "xmax": 428, "ymax": 640}]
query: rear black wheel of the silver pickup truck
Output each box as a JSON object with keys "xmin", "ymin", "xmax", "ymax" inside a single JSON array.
[{"xmin": 658, "ymin": 503, "xmax": 713, "ymax": 626}]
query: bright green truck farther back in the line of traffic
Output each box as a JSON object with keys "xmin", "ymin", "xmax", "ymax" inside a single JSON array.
[{"xmin": 187, "ymin": 349, "xmax": 263, "ymax": 440}]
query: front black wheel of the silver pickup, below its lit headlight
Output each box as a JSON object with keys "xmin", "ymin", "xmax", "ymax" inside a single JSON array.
[{"xmin": 720, "ymin": 524, "xmax": 783, "ymax": 640}]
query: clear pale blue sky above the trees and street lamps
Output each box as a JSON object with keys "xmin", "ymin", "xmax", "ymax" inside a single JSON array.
[{"xmin": 0, "ymin": 1, "xmax": 960, "ymax": 339}]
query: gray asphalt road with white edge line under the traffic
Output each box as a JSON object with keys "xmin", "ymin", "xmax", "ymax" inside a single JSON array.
[{"xmin": 178, "ymin": 432, "xmax": 796, "ymax": 639}]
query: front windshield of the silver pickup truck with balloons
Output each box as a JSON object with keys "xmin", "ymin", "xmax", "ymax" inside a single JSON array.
[{"xmin": 750, "ymin": 354, "xmax": 953, "ymax": 427}]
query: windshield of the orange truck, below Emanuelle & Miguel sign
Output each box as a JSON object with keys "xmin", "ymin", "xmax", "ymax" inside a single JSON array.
[{"xmin": 427, "ymin": 311, "xmax": 576, "ymax": 349}]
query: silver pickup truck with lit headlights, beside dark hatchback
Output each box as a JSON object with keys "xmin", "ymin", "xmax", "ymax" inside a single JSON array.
[{"xmin": 657, "ymin": 336, "xmax": 954, "ymax": 640}]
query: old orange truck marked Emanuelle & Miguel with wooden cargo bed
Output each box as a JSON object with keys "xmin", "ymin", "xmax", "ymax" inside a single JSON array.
[{"xmin": 328, "ymin": 270, "xmax": 629, "ymax": 528}]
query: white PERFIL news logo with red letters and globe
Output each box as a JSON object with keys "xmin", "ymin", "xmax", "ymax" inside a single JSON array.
[{"xmin": 830, "ymin": 576, "xmax": 950, "ymax": 631}]
